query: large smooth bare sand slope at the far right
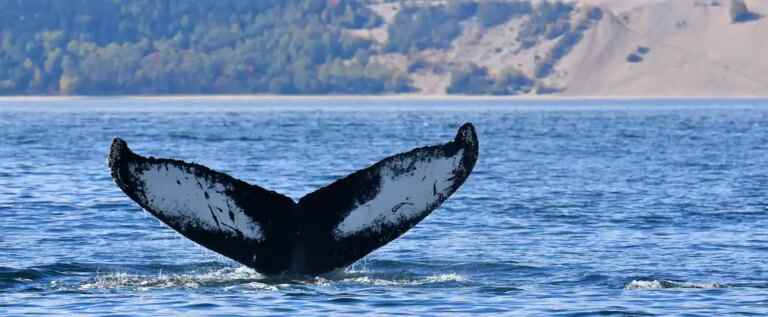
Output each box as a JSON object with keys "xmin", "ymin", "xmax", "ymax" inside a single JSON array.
[{"xmin": 558, "ymin": 0, "xmax": 768, "ymax": 96}]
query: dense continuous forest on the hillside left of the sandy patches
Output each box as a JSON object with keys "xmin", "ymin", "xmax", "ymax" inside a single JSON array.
[{"xmin": 0, "ymin": 0, "xmax": 411, "ymax": 94}]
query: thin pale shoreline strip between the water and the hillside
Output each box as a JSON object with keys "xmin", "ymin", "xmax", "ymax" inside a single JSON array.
[{"xmin": 0, "ymin": 94, "xmax": 768, "ymax": 103}]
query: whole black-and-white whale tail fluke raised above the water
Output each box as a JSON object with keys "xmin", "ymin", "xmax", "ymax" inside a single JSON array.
[{"xmin": 108, "ymin": 123, "xmax": 479, "ymax": 274}]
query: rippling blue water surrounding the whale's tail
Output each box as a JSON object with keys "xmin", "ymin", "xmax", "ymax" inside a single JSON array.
[{"xmin": 0, "ymin": 98, "xmax": 768, "ymax": 316}]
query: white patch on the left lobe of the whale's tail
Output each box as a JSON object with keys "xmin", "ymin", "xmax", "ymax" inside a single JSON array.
[{"xmin": 132, "ymin": 163, "xmax": 264, "ymax": 241}]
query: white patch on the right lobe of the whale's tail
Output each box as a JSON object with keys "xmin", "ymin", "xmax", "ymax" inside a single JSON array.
[{"xmin": 334, "ymin": 150, "xmax": 464, "ymax": 239}]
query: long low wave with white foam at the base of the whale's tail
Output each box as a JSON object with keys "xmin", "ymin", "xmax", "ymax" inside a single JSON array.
[{"xmin": 0, "ymin": 261, "xmax": 468, "ymax": 292}]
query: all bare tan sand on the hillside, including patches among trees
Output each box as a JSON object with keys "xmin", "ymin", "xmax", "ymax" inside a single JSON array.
[{"xmin": 360, "ymin": 0, "xmax": 768, "ymax": 96}]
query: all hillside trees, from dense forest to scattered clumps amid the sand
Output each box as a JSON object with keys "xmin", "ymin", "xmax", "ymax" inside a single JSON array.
[{"xmin": 0, "ymin": 0, "xmax": 601, "ymax": 95}]
